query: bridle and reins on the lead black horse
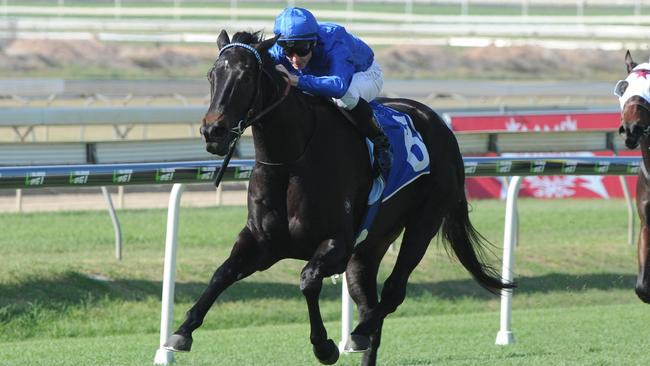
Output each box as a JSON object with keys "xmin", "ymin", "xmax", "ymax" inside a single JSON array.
[{"xmin": 209, "ymin": 42, "xmax": 291, "ymax": 187}]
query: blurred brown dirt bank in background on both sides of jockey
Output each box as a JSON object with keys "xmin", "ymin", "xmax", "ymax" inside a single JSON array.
[{"xmin": 0, "ymin": 40, "xmax": 625, "ymax": 80}]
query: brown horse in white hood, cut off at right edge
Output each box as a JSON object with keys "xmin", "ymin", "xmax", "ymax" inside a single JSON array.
[{"xmin": 614, "ymin": 51, "xmax": 650, "ymax": 304}]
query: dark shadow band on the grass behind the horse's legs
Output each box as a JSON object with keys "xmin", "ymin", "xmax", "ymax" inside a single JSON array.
[{"xmin": 0, "ymin": 272, "xmax": 635, "ymax": 322}]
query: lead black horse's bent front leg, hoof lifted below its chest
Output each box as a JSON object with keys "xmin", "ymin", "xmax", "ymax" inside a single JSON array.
[{"xmin": 300, "ymin": 239, "xmax": 347, "ymax": 365}]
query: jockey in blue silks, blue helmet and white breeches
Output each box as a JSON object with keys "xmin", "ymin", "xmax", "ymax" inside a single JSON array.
[{"xmin": 269, "ymin": 7, "xmax": 393, "ymax": 173}]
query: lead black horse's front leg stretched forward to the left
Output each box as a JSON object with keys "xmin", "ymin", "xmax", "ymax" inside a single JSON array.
[{"xmin": 163, "ymin": 228, "xmax": 278, "ymax": 352}]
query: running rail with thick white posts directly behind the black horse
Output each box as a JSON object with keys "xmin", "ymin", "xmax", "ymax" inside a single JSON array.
[{"xmin": 0, "ymin": 156, "xmax": 642, "ymax": 364}]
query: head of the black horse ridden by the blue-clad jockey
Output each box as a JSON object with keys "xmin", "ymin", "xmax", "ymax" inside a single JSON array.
[{"xmin": 201, "ymin": 30, "xmax": 275, "ymax": 155}]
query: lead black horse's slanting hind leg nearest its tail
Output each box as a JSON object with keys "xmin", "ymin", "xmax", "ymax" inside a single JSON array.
[{"xmin": 347, "ymin": 210, "xmax": 443, "ymax": 365}]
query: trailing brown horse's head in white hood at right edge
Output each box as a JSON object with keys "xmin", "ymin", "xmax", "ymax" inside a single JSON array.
[{"xmin": 614, "ymin": 51, "xmax": 650, "ymax": 149}]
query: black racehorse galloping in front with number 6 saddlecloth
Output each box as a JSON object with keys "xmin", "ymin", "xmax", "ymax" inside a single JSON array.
[{"xmin": 165, "ymin": 31, "xmax": 513, "ymax": 365}]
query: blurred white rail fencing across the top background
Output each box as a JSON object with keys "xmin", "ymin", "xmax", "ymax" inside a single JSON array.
[{"xmin": 0, "ymin": 0, "xmax": 650, "ymax": 49}]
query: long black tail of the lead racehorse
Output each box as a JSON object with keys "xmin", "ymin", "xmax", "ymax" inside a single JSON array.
[{"xmin": 442, "ymin": 192, "xmax": 516, "ymax": 293}]
